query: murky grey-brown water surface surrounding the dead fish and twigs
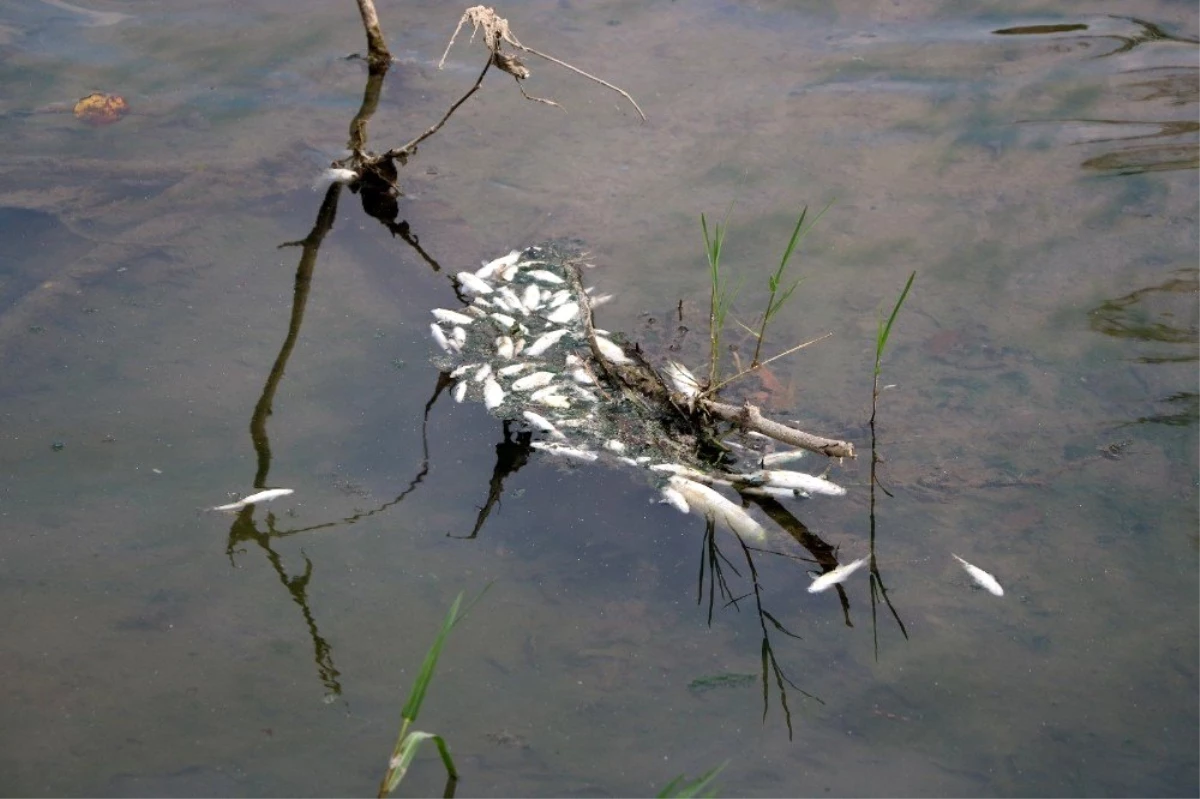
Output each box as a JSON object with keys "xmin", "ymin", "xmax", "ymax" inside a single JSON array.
[{"xmin": 0, "ymin": 0, "xmax": 1200, "ymax": 797}]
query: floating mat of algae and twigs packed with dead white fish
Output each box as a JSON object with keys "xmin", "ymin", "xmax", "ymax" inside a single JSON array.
[{"xmin": 431, "ymin": 244, "xmax": 853, "ymax": 543}]
